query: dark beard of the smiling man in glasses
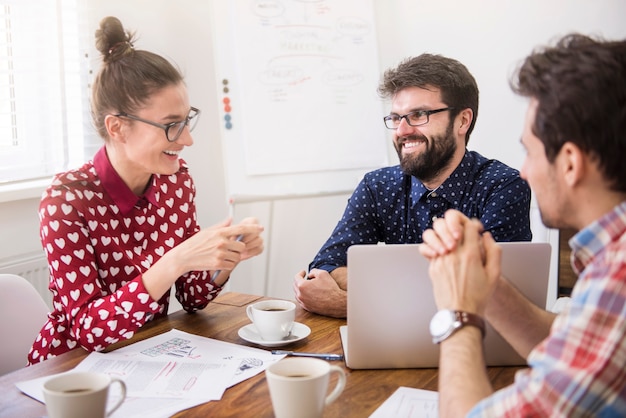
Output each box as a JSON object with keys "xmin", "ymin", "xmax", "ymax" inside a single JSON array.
[{"xmin": 395, "ymin": 119, "xmax": 457, "ymax": 183}]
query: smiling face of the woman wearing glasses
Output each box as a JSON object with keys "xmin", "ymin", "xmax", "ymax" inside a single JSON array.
[{"xmin": 107, "ymin": 83, "xmax": 193, "ymax": 194}]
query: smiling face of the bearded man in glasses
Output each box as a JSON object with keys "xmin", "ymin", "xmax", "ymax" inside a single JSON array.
[{"xmin": 390, "ymin": 87, "xmax": 465, "ymax": 187}]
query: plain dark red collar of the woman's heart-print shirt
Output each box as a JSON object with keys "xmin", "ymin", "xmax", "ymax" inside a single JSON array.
[{"xmin": 93, "ymin": 147, "xmax": 158, "ymax": 214}]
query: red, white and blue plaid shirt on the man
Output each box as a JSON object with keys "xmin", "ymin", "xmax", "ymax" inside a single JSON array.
[{"xmin": 469, "ymin": 201, "xmax": 626, "ymax": 417}]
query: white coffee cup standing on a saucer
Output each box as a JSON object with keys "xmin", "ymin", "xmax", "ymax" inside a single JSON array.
[{"xmin": 246, "ymin": 300, "xmax": 296, "ymax": 341}]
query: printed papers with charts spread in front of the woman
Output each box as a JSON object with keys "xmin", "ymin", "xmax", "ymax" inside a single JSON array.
[{"xmin": 17, "ymin": 330, "xmax": 284, "ymax": 417}]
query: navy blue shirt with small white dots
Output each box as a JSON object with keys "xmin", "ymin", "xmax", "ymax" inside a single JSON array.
[{"xmin": 310, "ymin": 151, "xmax": 532, "ymax": 271}]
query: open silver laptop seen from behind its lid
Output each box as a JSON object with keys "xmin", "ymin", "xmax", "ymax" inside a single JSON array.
[{"xmin": 340, "ymin": 242, "xmax": 551, "ymax": 369}]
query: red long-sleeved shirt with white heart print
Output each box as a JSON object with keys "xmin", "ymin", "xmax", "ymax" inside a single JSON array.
[{"xmin": 28, "ymin": 147, "xmax": 222, "ymax": 364}]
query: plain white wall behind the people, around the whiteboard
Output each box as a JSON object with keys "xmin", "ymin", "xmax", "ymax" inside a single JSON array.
[{"xmin": 0, "ymin": 0, "xmax": 626, "ymax": 304}]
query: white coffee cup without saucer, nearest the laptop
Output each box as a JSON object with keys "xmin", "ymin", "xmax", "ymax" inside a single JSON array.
[{"xmin": 265, "ymin": 357, "xmax": 346, "ymax": 418}]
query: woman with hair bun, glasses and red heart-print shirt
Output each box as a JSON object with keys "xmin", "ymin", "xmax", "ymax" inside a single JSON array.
[{"xmin": 28, "ymin": 17, "xmax": 263, "ymax": 364}]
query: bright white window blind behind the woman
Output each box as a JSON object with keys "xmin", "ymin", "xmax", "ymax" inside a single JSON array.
[{"xmin": 0, "ymin": 0, "xmax": 95, "ymax": 183}]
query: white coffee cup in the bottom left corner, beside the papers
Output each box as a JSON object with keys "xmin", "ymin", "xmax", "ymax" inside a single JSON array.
[{"xmin": 43, "ymin": 372, "xmax": 126, "ymax": 418}]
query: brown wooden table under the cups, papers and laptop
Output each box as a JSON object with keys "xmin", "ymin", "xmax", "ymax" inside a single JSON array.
[{"xmin": 0, "ymin": 293, "xmax": 520, "ymax": 418}]
